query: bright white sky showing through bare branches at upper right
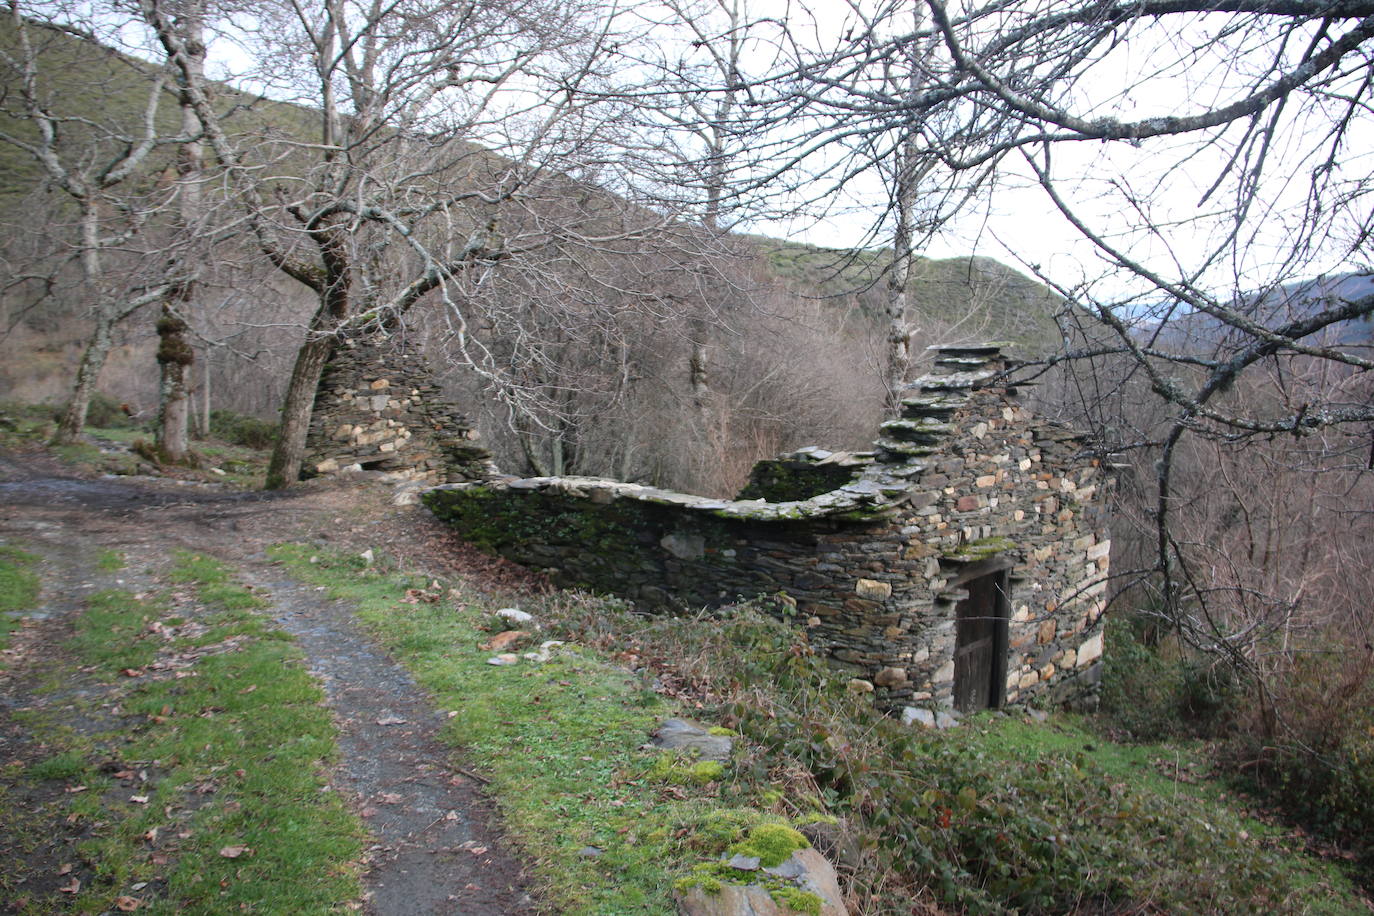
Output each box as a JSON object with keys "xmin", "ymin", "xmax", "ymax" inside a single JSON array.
[{"xmin": 749, "ymin": 0, "xmax": 1374, "ymax": 295}]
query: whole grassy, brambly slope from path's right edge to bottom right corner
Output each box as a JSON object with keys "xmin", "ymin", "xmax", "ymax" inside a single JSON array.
[{"xmin": 262, "ymin": 545, "xmax": 1360, "ymax": 915}]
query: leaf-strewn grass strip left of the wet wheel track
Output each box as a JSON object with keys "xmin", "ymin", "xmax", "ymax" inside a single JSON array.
[{"xmin": 0, "ymin": 553, "xmax": 364, "ymax": 915}]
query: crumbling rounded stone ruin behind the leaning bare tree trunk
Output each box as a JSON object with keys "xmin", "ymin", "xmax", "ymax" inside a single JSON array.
[{"xmin": 302, "ymin": 338, "xmax": 496, "ymax": 483}]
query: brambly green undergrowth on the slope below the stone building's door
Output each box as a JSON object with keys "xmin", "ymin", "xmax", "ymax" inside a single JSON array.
[{"xmin": 508, "ymin": 585, "xmax": 1362, "ymax": 913}]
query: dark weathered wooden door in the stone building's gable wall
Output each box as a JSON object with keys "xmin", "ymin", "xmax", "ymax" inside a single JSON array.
[{"xmin": 951, "ymin": 558, "xmax": 1011, "ymax": 713}]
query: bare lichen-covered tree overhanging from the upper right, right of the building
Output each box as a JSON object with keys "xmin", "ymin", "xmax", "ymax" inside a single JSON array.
[{"xmin": 757, "ymin": 0, "xmax": 1374, "ymax": 666}]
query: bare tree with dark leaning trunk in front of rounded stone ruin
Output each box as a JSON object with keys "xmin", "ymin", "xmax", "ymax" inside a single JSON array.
[{"xmin": 143, "ymin": 0, "xmax": 654, "ymax": 486}]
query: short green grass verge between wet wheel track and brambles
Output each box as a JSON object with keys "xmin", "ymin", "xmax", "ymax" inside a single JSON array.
[{"xmin": 273, "ymin": 545, "xmax": 813, "ymax": 915}]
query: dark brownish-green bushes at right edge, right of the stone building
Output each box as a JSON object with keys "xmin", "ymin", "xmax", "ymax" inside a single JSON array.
[{"xmin": 1103, "ymin": 612, "xmax": 1374, "ymax": 893}]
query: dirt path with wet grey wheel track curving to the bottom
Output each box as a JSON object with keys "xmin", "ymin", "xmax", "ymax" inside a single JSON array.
[{"xmin": 0, "ymin": 456, "xmax": 534, "ymax": 916}]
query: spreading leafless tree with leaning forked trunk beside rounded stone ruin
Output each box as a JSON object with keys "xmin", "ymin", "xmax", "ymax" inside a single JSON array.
[{"xmin": 143, "ymin": 0, "xmax": 736, "ymax": 486}]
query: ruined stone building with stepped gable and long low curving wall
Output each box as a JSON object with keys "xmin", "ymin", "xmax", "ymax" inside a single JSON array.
[{"xmin": 423, "ymin": 346, "xmax": 1110, "ymax": 709}]
